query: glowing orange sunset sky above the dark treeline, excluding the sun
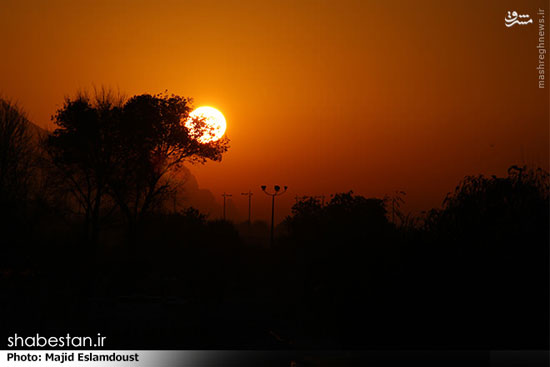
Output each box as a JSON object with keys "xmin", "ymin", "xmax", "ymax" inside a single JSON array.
[{"xmin": 0, "ymin": 0, "xmax": 550, "ymax": 223}]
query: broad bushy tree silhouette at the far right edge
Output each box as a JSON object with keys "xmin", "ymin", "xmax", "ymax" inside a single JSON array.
[{"xmin": 428, "ymin": 166, "xmax": 550, "ymax": 243}]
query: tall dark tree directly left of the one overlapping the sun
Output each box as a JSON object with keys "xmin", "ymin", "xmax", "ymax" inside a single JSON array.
[{"xmin": 45, "ymin": 89, "xmax": 123, "ymax": 244}]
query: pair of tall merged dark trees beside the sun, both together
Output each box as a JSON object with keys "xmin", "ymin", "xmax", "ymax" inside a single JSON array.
[{"xmin": 46, "ymin": 89, "xmax": 228, "ymax": 247}]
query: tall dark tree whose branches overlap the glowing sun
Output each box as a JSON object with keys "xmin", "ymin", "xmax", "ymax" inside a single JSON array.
[{"xmin": 109, "ymin": 94, "xmax": 229, "ymax": 243}]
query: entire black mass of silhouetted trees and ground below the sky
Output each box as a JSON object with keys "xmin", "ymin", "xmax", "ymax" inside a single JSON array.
[{"xmin": 0, "ymin": 93, "xmax": 550, "ymax": 349}]
